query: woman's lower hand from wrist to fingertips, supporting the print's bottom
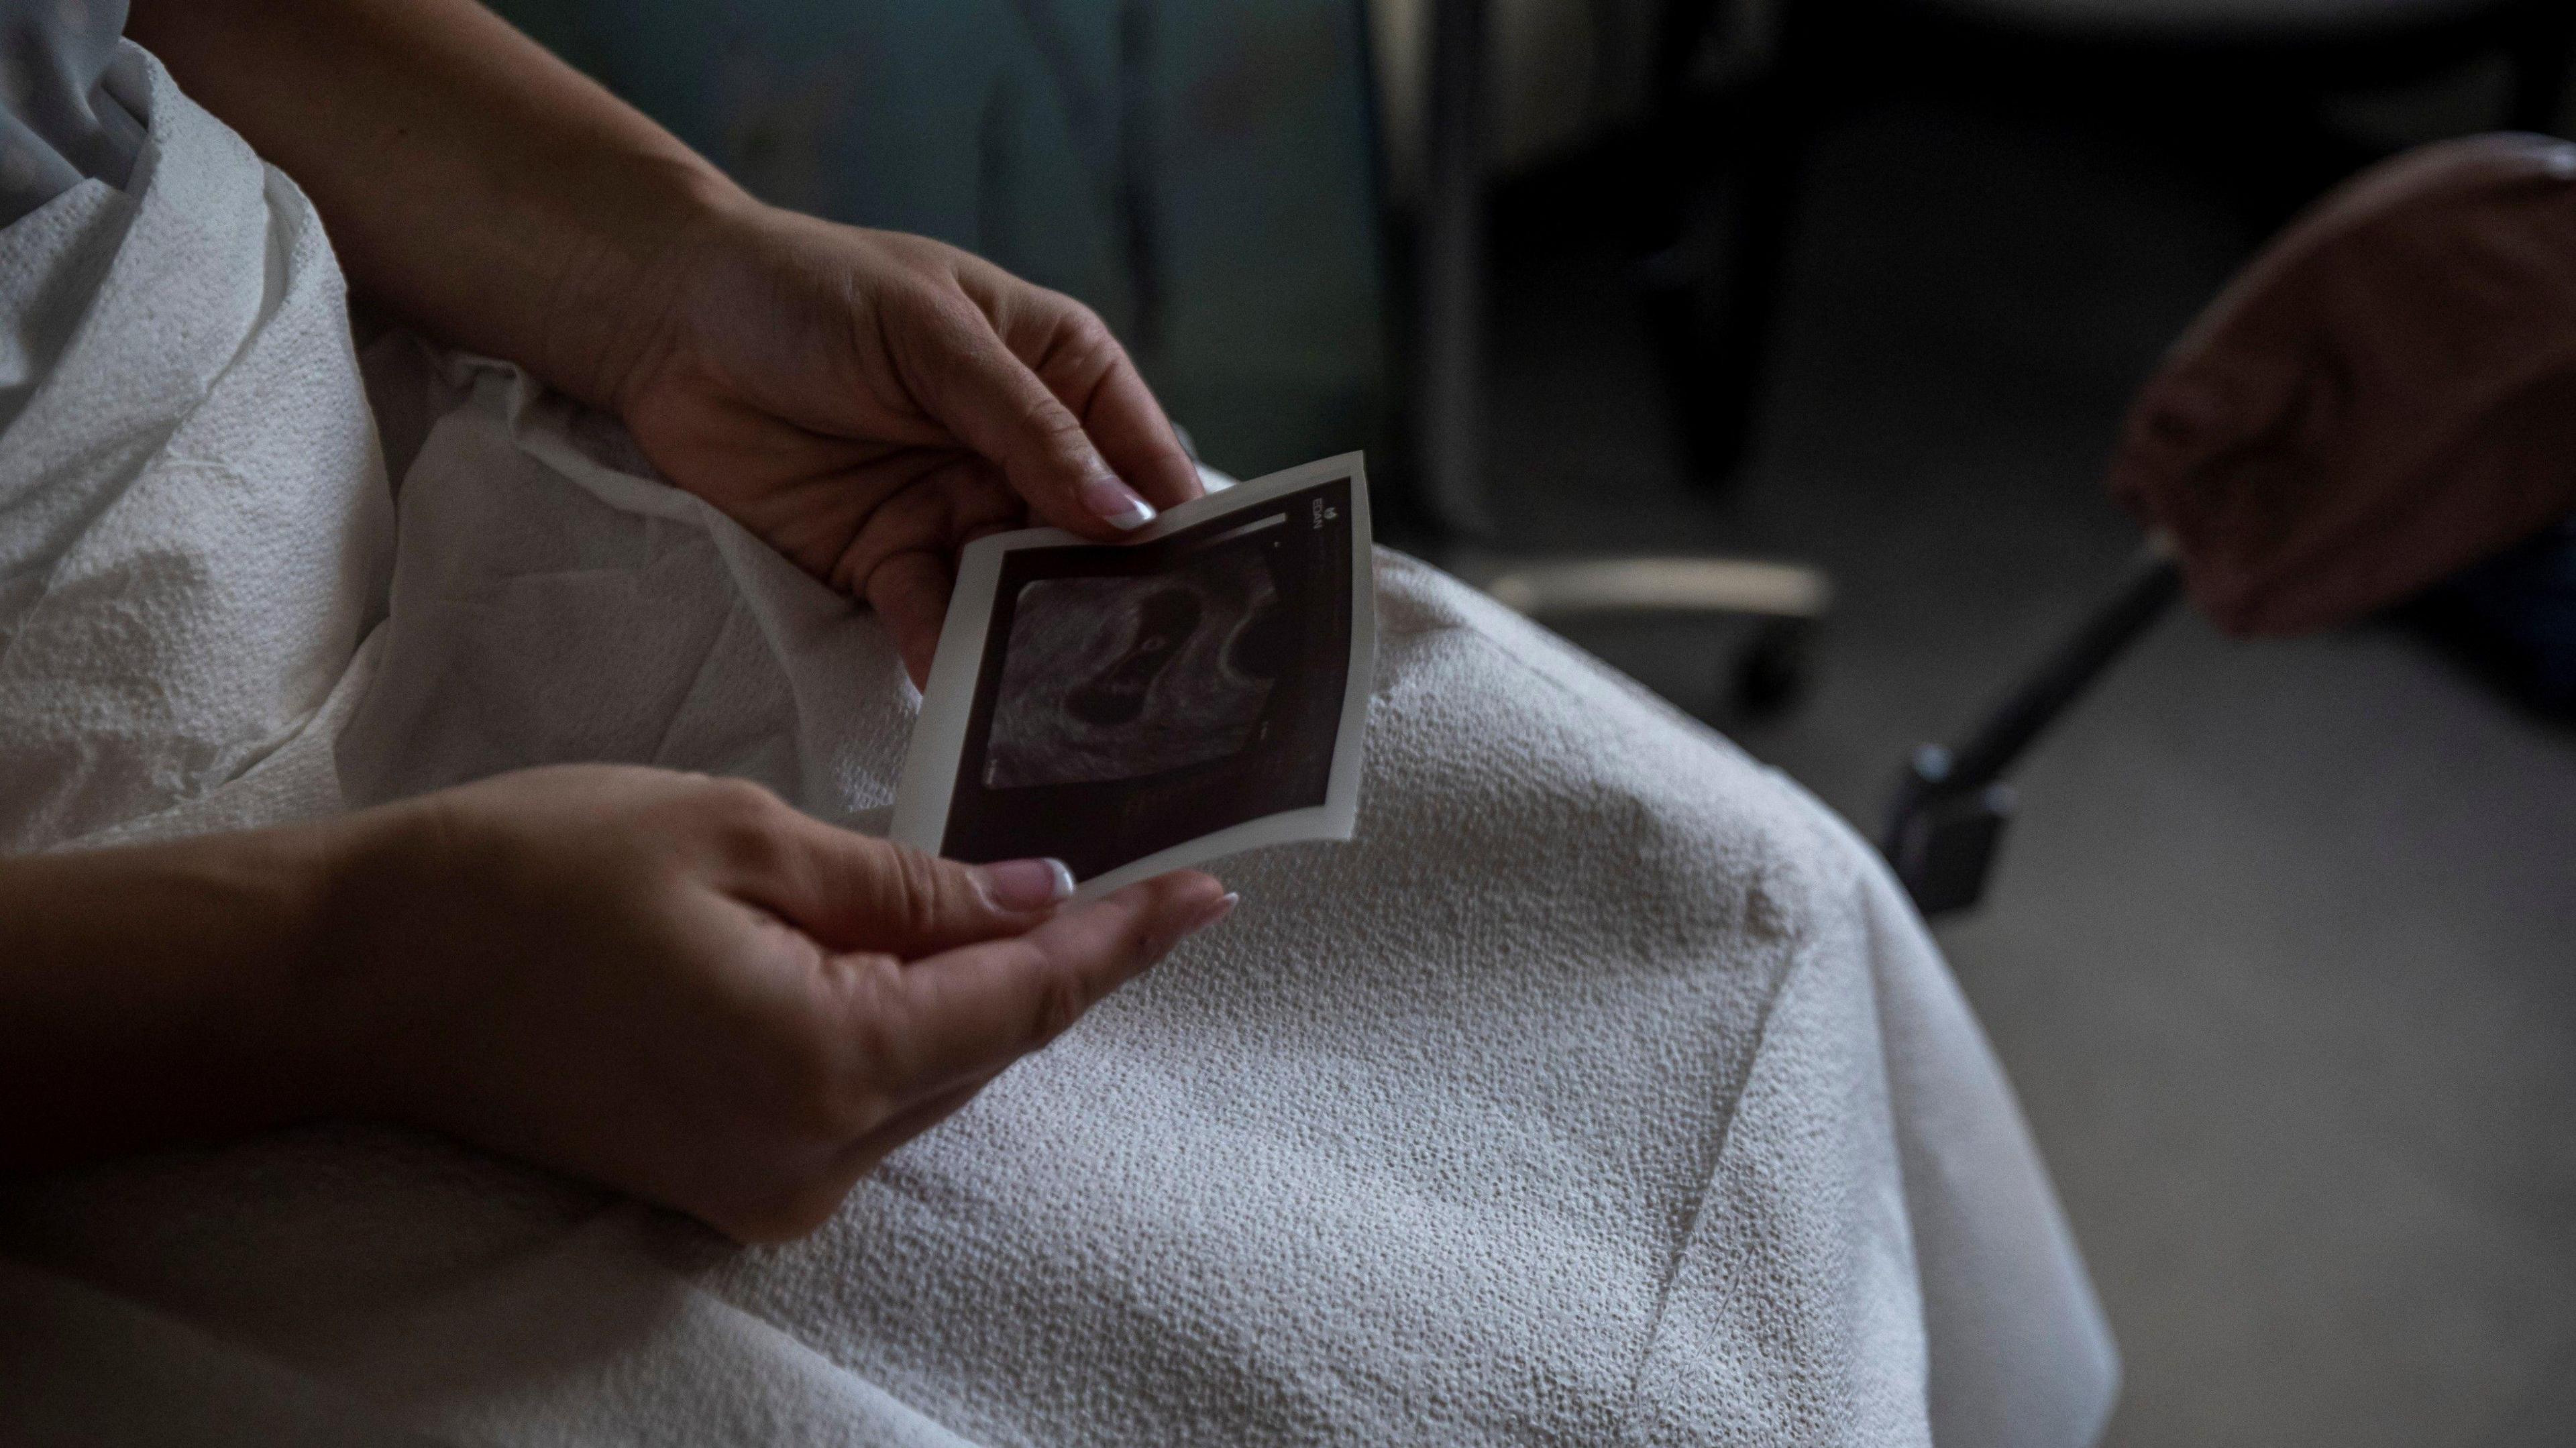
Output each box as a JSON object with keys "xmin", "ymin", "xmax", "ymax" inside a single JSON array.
[{"xmin": 314, "ymin": 765, "xmax": 1234, "ymax": 1242}]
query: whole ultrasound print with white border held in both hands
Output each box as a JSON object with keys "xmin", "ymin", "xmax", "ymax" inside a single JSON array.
[{"xmin": 894, "ymin": 453, "xmax": 1376, "ymax": 894}]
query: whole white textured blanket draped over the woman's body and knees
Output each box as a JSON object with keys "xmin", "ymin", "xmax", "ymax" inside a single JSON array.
[{"xmin": 0, "ymin": 52, "xmax": 2115, "ymax": 1448}]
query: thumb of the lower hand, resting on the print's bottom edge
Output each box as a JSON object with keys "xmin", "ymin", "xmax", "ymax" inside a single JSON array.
[{"xmin": 739, "ymin": 814, "xmax": 1074, "ymax": 961}]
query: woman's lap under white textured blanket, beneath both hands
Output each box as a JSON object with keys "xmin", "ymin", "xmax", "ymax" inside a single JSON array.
[{"xmin": 0, "ymin": 353, "xmax": 2102, "ymax": 1443}]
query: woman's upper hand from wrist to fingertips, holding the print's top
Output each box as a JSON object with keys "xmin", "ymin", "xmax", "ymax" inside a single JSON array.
[{"xmin": 603, "ymin": 201, "xmax": 1200, "ymax": 680}]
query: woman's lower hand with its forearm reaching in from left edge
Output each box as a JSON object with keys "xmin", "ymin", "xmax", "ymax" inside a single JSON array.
[{"xmin": 0, "ymin": 765, "xmax": 1234, "ymax": 1239}]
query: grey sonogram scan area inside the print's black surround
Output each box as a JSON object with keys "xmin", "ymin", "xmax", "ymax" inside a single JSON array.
[{"xmin": 984, "ymin": 539, "xmax": 1291, "ymax": 789}]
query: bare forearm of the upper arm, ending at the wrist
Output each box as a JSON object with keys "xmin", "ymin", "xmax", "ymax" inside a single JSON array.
[{"xmin": 129, "ymin": 0, "xmax": 745, "ymax": 404}]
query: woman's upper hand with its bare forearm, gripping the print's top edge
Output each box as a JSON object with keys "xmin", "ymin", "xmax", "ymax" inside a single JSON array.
[{"xmin": 129, "ymin": 0, "xmax": 1198, "ymax": 677}]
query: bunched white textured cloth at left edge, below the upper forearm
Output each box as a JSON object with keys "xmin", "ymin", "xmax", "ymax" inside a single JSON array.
[{"xmin": 0, "ymin": 44, "xmax": 392, "ymax": 850}]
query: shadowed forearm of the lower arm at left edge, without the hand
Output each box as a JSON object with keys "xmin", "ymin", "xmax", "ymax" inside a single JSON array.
[{"xmin": 0, "ymin": 824, "xmax": 350, "ymax": 1170}]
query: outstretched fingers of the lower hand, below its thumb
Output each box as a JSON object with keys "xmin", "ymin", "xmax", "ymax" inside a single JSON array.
[{"xmin": 868, "ymin": 871, "xmax": 1234, "ymax": 1093}]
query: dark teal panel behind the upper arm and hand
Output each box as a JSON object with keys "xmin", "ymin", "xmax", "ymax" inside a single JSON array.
[{"xmin": 497, "ymin": 0, "xmax": 1389, "ymax": 474}]
